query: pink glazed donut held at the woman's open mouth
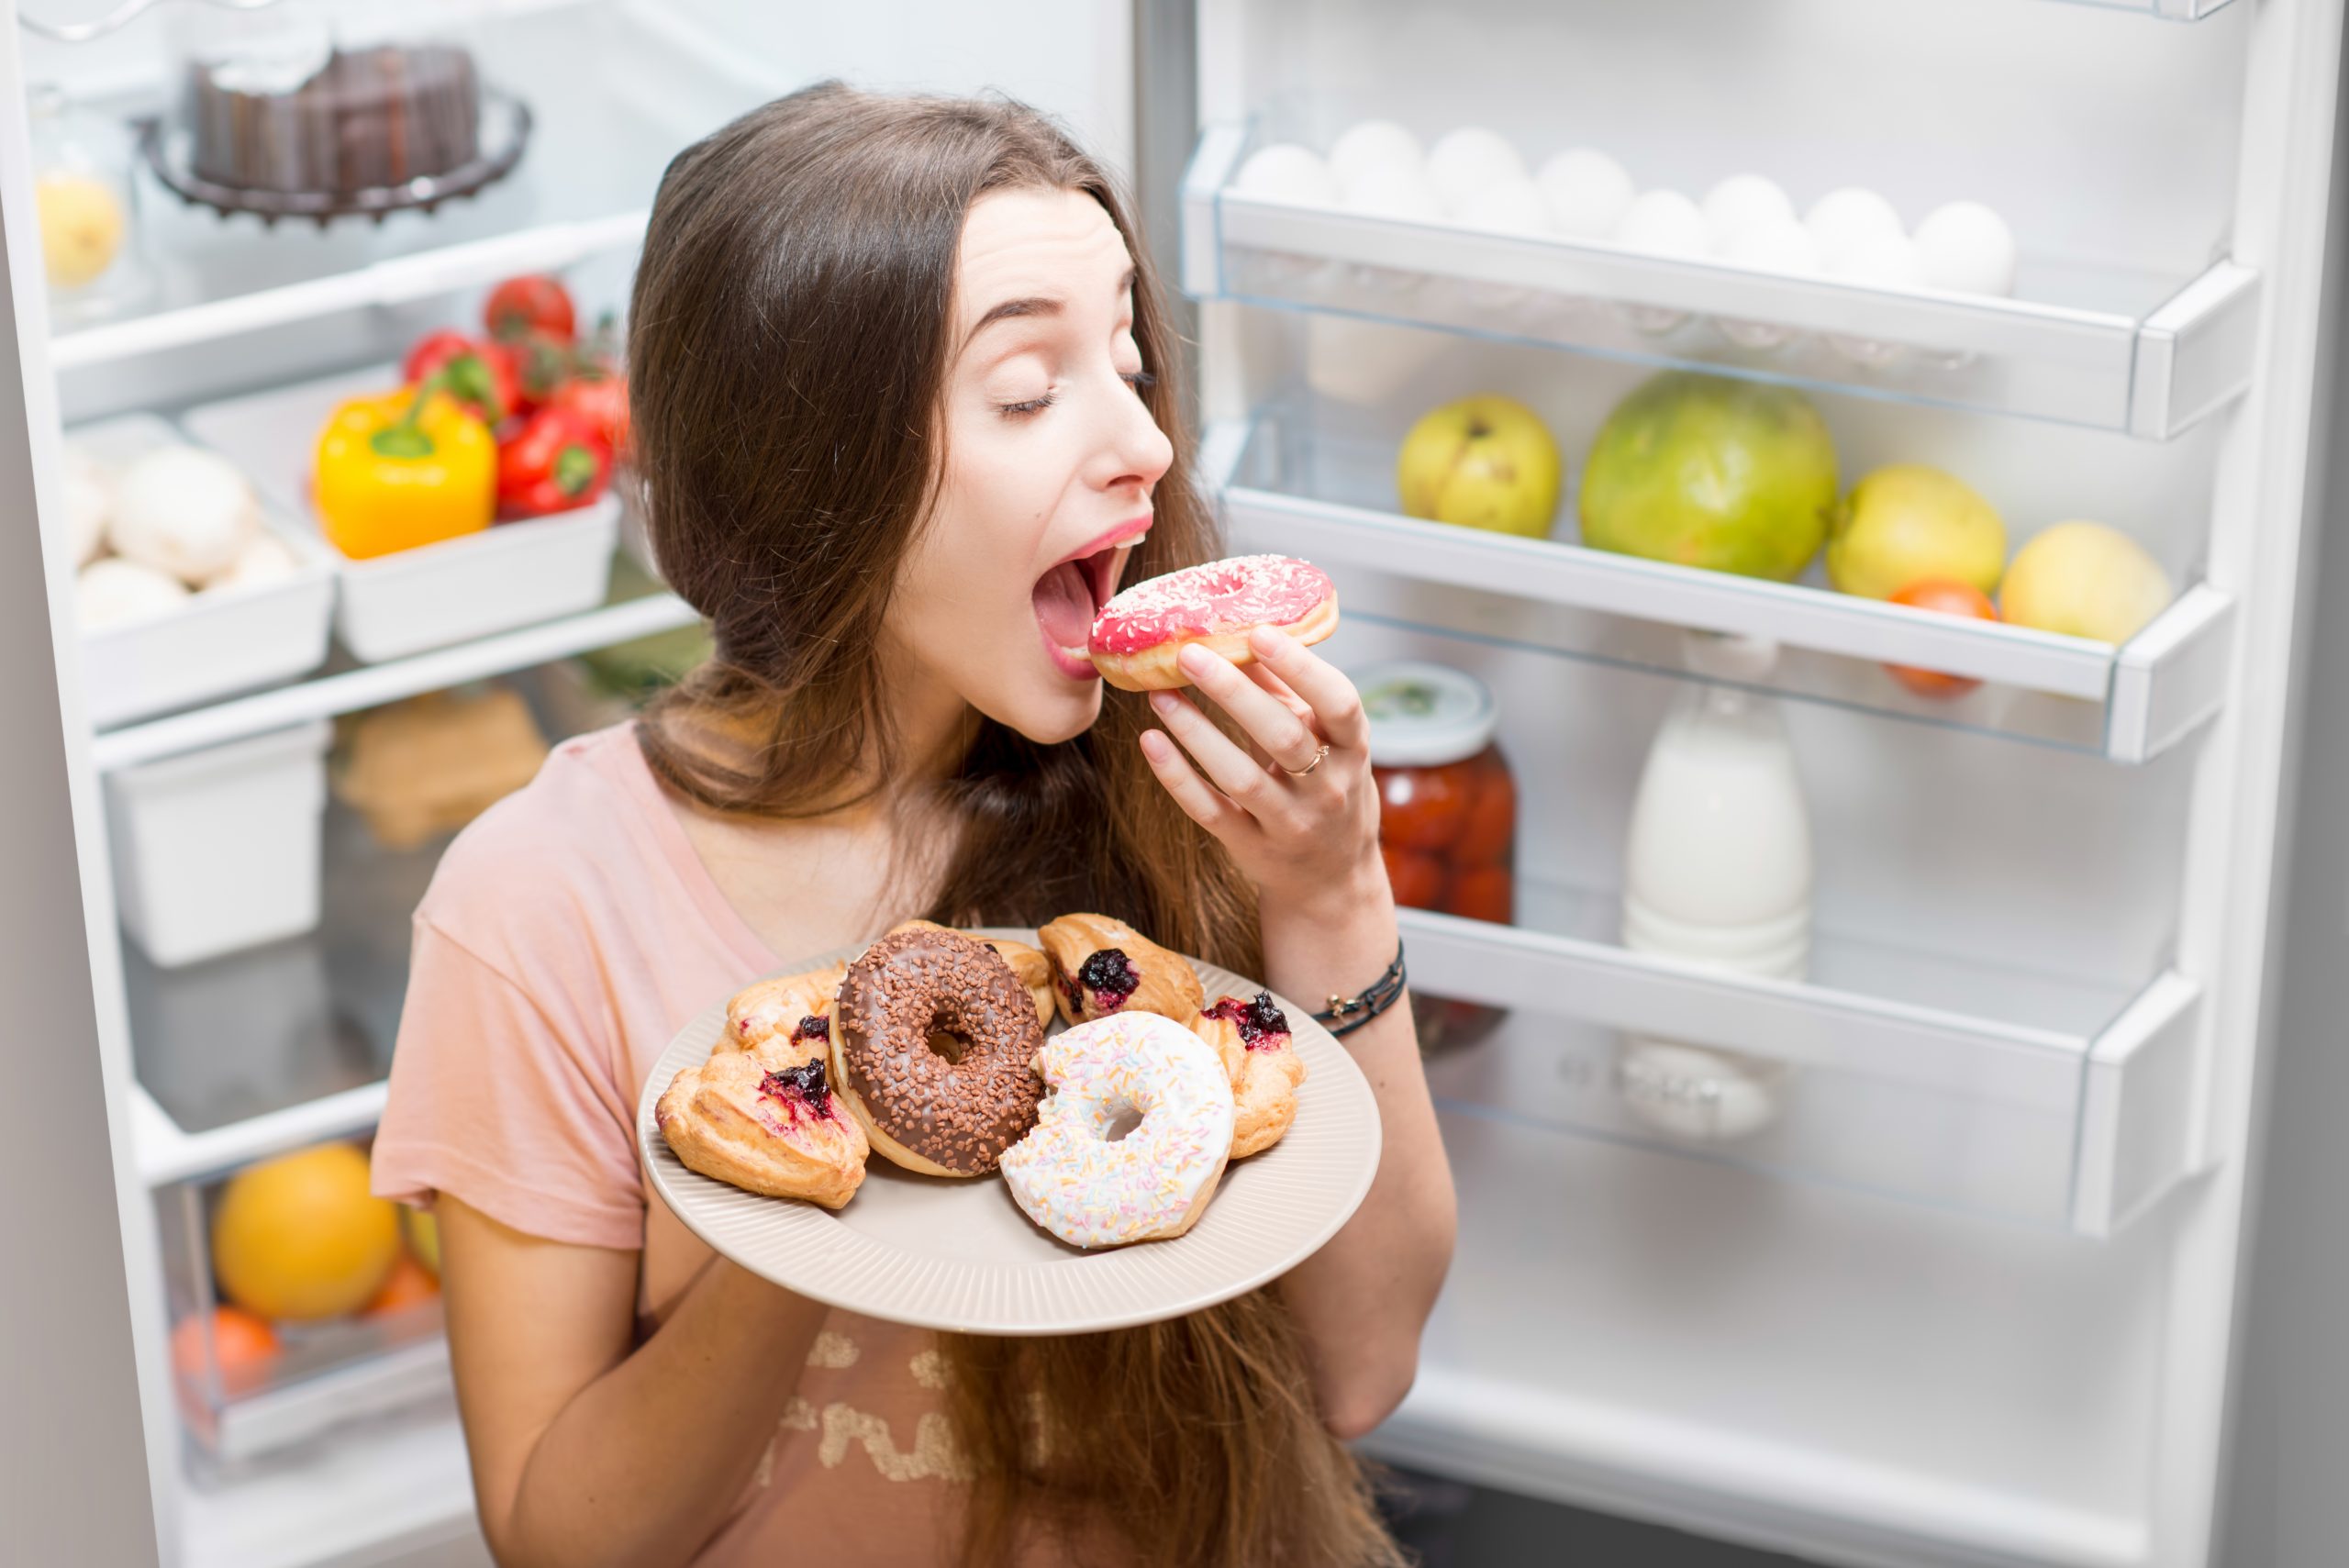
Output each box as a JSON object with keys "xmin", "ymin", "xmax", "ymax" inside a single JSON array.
[{"xmin": 1087, "ymin": 556, "xmax": 1337, "ymax": 693}]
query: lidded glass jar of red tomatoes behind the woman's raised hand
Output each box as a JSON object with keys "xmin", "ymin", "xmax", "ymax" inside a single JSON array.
[{"xmin": 1355, "ymin": 662, "xmax": 1518, "ymax": 1051}]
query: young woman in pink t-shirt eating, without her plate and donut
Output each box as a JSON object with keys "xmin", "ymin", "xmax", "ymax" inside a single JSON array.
[{"xmin": 373, "ymin": 84, "xmax": 1454, "ymax": 1568}]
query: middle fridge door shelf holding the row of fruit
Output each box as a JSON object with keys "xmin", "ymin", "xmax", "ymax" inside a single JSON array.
[{"xmin": 1200, "ymin": 420, "xmax": 2234, "ymax": 762}]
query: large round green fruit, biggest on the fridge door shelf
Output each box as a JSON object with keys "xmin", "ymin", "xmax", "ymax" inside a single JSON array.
[{"xmin": 1581, "ymin": 371, "xmax": 1834, "ymax": 582}]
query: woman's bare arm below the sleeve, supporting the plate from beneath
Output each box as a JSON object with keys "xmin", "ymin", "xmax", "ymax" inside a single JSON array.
[{"xmin": 437, "ymin": 1195, "xmax": 825, "ymax": 1568}]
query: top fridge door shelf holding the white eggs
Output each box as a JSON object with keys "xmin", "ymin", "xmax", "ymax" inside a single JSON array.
[{"xmin": 1182, "ymin": 125, "xmax": 2260, "ymax": 439}]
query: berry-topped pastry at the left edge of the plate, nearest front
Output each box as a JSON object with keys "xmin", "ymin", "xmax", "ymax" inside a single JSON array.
[{"xmin": 653, "ymin": 1050, "xmax": 872, "ymax": 1209}]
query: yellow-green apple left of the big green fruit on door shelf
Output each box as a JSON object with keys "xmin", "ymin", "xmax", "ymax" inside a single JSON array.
[{"xmin": 1396, "ymin": 395, "xmax": 1560, "ymax": 539}]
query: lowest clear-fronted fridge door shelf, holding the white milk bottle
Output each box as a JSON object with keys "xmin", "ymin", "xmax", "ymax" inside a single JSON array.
[{"xmin": 1402, "ymin": 880, "xmax": 2201, "ymax": 1237}]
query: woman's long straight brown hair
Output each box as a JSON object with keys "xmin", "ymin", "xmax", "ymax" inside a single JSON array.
[{"xmin": 629, "ymin": 83, "xmax": 1400, "ymax": 1568}]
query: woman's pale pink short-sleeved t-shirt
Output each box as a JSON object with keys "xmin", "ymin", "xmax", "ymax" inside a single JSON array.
[{"xmin": 373, "ymin": 726, "xmax": 965, "ymax": 1568}]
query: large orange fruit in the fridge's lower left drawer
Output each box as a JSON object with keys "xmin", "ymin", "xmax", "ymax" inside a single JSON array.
[{"xmin": 211, "ymin": 1143, "xmax": 399, "ymax": 1321}]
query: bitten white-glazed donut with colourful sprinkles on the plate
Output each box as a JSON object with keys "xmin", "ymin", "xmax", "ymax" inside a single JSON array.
[{"xmin": 1001, "ymin": 1012, "xmax": 1230, "ymax": 1247}]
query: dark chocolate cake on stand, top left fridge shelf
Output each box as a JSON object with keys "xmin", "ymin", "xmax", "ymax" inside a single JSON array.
[{"xmin": 188, "ymin": 45, "xmax": 482, "ymax": 195}]
